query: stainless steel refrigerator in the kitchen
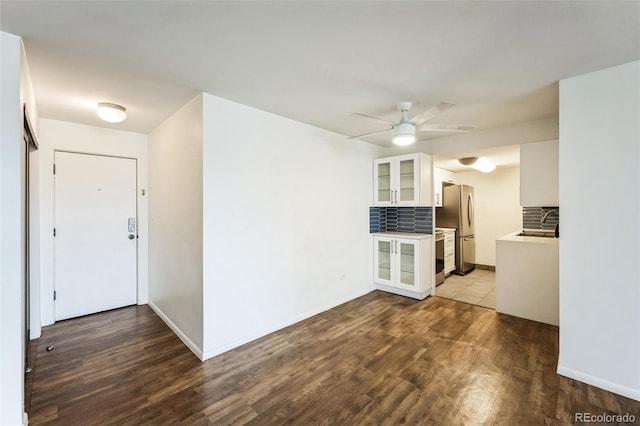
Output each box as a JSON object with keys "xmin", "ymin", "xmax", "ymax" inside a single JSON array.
[{"xmin": 436, "ymin": 185, "xmax": 476, "ymax": 275}]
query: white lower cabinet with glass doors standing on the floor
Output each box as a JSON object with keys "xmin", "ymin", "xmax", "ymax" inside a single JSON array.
[{"xmin": 373, "ymin": 232, "xmax": 435, "ymax": 300}]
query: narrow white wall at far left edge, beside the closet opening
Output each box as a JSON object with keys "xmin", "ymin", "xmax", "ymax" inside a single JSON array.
[{"xmin": 0, "ymin": 32, "xmax": 38, "ymax": 425}]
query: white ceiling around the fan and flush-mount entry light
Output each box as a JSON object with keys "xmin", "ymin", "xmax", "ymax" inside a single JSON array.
[{"xmin": 0, "ymin": 0, "xmax": 640, "ymax": 145}]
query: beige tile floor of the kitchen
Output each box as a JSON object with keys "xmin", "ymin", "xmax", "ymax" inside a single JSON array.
[{"xmin": 436, "ymin": 269, "xmax": 496, "ymax": 309}]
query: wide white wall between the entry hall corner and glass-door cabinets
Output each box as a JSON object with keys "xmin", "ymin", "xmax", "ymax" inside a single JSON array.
[{"xmin": 203, "ymin": 94, "xmax": 381, "ymax": 359}]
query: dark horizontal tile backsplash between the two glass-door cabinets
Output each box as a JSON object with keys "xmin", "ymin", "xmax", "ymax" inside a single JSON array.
[{"xmin": 369, "ymin": 207, "xmax": 433, "ymax": 234}]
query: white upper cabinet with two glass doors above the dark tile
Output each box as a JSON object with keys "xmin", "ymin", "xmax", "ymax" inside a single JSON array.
[{"xmin": 373, "ymin": 153, "xmax": 433, "ymax": 207}]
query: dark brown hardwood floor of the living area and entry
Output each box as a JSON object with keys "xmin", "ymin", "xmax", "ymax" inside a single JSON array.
[{"xmin": 27, "ymin": 291, "xmax": 640, "ymax": 426}]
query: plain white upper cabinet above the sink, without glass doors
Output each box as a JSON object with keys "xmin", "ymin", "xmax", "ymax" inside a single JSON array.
[{"xmin": 520, "ymin": 139, "xmax": 560, "ymax": 207}]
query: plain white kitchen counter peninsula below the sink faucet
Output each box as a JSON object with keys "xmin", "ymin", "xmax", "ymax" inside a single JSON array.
[{"xmin": 496, "ymin": 231, "xmax": 559, "ymax": 325}]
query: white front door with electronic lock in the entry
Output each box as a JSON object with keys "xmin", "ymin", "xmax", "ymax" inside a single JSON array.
[{"xmin": 54, "ymin": 152, "xmax": 137, "ymax": 320}]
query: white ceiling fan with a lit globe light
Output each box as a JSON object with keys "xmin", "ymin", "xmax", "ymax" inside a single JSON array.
[{"xmin": 347, "ymin": 101, "xmax": 475, "ymax": 145}]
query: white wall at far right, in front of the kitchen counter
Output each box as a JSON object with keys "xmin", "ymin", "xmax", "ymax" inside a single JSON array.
[{"xmin": 558, "ymin": 62, "xmax": 640, "ymax": 400}]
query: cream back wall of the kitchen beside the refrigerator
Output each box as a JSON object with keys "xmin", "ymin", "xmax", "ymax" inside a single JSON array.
[{"xmin": 456, "ymin": 167, "xmax": 522, "ymax": 266}]
